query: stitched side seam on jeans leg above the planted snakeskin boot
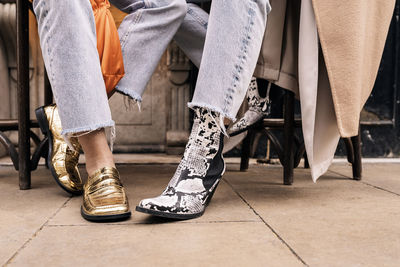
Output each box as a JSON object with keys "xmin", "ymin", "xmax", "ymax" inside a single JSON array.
[{"xmin": 223, "ymin": 0, "xmax": 257, "ymax": 116}]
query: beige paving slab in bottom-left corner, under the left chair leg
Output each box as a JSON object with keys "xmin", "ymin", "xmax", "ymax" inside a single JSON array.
[{"xmin": 0, "ymin": 167, "xmax": 69, "ymax": 266}]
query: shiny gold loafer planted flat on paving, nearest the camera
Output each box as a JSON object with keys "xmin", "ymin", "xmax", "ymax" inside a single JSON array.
[{"xmin": 81, "ymin": 167, "xmax": 131, "ymax": 222}]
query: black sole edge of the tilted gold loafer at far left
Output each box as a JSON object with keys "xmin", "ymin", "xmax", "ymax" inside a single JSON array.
[{"xmin": 35, "ymin": 106, "xmax": 83, "ymax": 196}]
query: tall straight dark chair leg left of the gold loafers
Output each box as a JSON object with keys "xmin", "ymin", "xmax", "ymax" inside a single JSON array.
[{"xmin": 16, "ymin": 0, "xmax": 31, "ymax": 190}]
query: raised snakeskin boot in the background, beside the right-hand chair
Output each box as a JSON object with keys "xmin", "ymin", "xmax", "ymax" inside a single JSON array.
[{"xmin": 228, "ymin": 78, "xmax": 271, "ymax": 136}]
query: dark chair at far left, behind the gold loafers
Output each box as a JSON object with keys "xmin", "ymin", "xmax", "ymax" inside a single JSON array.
[{"xmin": 0, "ymin": 0, "xmax": 53, "ymax": 190}]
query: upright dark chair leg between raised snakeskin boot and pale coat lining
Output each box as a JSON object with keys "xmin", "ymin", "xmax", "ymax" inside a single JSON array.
[{"xmin": 283, "ymin": 91, "xmax": 295, "ymax": 185}]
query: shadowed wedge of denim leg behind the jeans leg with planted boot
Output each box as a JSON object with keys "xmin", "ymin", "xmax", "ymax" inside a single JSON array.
[{"xmin": 174, "ymin": 3, "xmax": 208, "ymax": 68}]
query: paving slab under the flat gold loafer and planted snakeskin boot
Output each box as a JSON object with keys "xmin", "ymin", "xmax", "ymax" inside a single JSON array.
[{"xmin": 49, "ymin": 165, "xmax": 260, "ymax": 225}]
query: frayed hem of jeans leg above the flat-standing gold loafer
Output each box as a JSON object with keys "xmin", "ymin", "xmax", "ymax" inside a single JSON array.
[{"xmin": 61, "ymin": 121, "xmax": 116, "ymax": 152}]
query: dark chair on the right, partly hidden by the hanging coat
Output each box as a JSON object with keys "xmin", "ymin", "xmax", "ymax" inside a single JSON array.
[{"xmin": 240, "ymin": 82, "xmax": 362, "ymax": 185}]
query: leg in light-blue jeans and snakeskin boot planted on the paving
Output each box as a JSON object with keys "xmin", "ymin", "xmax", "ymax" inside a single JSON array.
[{"xmin": 136, "ymin": 0, "xmax": 270, "ymax": 219}]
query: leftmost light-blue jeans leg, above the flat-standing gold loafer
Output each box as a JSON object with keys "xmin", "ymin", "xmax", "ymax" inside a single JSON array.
[{"xmin": 33, "ymin": 0, "xmax": 114, "ymax": 135}]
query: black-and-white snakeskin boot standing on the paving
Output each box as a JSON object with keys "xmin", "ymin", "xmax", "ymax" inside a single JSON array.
[{"xmin": 136, "ymin": 108, "xmax": 225, "ymax": 220}]
